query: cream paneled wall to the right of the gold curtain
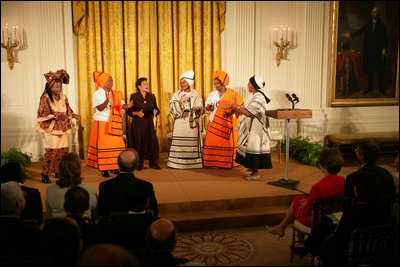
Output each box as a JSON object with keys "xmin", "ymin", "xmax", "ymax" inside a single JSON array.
[{"xmin": 221, "ymin": 1, "xmax": 399, "ymax": 140}]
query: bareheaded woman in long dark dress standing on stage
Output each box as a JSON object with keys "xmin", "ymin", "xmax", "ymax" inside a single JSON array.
[{"xmin": 127, "ymin": 78, "xmax": 161, "ymax": 171}]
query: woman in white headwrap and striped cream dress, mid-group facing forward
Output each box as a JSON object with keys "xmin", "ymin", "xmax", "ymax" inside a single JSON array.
[{"xmin": 167, "ymin": 70, "xmax": 203, "ymax": 169}]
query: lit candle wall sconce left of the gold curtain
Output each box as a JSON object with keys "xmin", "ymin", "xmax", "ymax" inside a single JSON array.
[{"xmin": 1, "ymin": 23, "xmax": 22, "ymax": 69}]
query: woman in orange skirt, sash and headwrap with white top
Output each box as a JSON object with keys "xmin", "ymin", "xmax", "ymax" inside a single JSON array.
[{"xmin": 86, "ymin": 71, "xmax": 132, "ymax": 177}]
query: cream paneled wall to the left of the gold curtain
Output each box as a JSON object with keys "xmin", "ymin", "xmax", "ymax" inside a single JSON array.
[{"xmin": 1, "ymin": 1, "xmax": 79, "ymax": 161}]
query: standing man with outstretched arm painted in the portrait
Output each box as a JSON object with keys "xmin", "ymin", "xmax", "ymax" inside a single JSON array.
[{"xmin": 343, "ymin": 7, "xmax": 388, "ymax": 94}]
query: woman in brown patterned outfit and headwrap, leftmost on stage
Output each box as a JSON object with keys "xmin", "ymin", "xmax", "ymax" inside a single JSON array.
[{"xmin": 37, "ymin": 69, "xmax": 81, "ymax": 184}]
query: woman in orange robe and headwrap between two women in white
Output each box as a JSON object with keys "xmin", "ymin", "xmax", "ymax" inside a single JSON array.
[{"xmin": 203, "ymin": 70, "xmax": 244, "ymax": 169}]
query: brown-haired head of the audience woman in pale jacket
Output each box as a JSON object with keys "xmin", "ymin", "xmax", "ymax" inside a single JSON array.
[{"xmin": 56, "ymin": 152, "xmax": 82, "ymax": 187}]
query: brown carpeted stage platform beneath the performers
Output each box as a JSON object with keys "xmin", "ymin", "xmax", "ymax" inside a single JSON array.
[{"xmin": 25, "ymin": 152, "xmax": 356, "ymax": 232}]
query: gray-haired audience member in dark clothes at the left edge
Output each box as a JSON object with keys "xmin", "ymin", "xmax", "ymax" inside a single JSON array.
[{"xmin": 0, "ymin": 181, "xmax": 43, "ymax": 265}]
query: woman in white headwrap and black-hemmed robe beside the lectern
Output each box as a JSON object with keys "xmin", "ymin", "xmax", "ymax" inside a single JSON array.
[{"xmin": 224, "ymin": 75, "xmax": 272, "ymax": 180}]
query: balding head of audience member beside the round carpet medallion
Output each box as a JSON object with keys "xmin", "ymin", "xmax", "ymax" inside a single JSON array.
[{"xmin": 146, "ymin": 219, "xmax": 177, "ymax": 253}]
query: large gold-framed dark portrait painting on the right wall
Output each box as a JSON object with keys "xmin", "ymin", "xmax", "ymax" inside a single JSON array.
[{"xmin": 329, "ymin": 1, "xmax": 399, "ymax": 106}]
